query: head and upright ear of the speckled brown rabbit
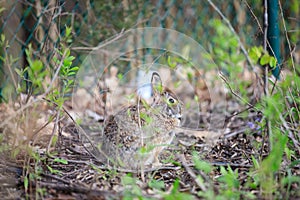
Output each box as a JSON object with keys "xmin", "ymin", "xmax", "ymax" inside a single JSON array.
[{"xmin": 151, "ymin": 72, "xmax": 182, "ymax": 125}]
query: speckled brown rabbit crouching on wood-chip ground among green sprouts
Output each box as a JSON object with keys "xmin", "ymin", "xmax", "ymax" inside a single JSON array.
[{"xmin": 98, "ymin": 72, "xmax": 182, "ymax": 169}]
